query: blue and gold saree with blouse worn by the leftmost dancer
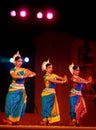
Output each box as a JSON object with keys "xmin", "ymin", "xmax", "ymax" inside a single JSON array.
[{"xmin": 5, "ymin": 68, "xmax": 27, "ymax": 122}]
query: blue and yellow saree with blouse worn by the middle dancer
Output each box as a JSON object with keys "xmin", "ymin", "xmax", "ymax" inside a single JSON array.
[{"xmin": 41, "ymin": 74, "xmax": 60, "ymax": 123}]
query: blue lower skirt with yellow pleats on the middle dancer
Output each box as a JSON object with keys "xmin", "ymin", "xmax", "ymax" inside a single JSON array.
[{"xmin": 42, "ymin": 88, "xmax": 60, "ymax": 123}]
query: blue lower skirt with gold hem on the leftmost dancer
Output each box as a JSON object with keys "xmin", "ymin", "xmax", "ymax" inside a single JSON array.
[{"xmin": 5, "ymin": 89, "xmax": 27, "ymax": 122}]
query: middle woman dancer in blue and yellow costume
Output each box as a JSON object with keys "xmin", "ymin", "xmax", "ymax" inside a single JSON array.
[{"xmin": 40, "ymin": 60, "xmax": 68, "ymax": 125}]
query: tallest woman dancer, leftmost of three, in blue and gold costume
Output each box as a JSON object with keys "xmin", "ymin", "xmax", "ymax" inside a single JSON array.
[{"xmin": 3, "ymin": 51, "xmax": 36, "ymax": 125}]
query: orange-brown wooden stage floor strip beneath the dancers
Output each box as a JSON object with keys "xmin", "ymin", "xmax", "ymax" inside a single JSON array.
[{"xmin": 0, "ymin": 125, "xmax": 96, "ymax": 130}]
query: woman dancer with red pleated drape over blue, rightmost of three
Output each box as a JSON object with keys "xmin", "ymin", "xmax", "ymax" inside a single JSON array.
[{"xmin": 69, "ymin": 63, "xmax": 92, "ymax": 126}]
